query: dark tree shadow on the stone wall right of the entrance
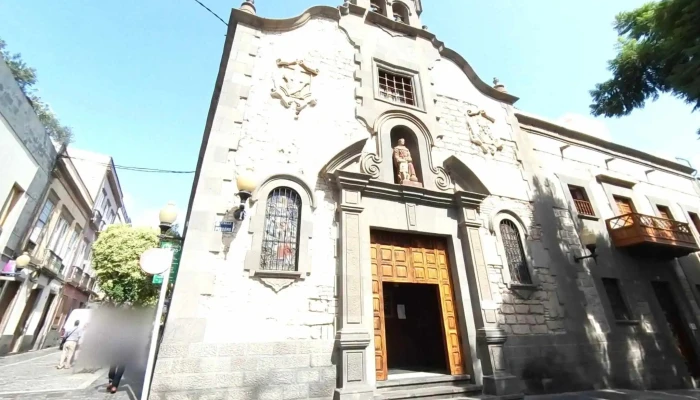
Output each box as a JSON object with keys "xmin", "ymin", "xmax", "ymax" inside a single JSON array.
[{"xmin": 506, "ymin": 178, "xmax": 688, "ymax": 394}]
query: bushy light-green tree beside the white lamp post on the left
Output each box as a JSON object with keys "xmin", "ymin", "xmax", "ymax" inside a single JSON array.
[{"xmin": 92, "ymin": 224, "xmax": 158, "ymax": 306}]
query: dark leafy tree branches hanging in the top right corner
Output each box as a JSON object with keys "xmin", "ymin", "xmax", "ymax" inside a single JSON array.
[{"xmin": 590, "ymin": 0, "xmax": 700, "ymax": 134}]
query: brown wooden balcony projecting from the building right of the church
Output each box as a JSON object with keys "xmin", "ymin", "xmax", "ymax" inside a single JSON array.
[{"xmin": 606, "ymin": 213, "xmax": 700, "ymax": 258}]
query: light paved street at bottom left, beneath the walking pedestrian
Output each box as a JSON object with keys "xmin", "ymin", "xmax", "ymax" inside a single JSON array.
[{"xmin": 0, "ymin": 348, "xmax": 141, "ymax": 400}]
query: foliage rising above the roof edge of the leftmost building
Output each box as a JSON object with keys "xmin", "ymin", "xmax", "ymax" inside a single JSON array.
[{"xmin": 0, "ymin": 39, "xmax": 73, "ymax": 144}]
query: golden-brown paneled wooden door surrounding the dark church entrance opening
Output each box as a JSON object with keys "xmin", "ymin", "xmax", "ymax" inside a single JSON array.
[{"xmin": 370, "ymin": 231, "xmax": 464, "ymax": 381}]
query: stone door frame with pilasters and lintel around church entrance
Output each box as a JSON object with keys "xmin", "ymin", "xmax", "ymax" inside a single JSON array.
[{"xmin": 327, "ymin": 170, "xmax": 521, "ymax": 399}]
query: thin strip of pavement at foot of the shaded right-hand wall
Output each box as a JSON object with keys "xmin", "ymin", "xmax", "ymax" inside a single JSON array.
[{"xmin": 525, "ymin": 389, "xmax": 700, "ymax": 400}]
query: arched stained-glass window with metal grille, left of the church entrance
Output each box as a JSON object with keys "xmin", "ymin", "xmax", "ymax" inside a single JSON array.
[{"xmin": 260, "ymin": 187, "xmax": 301, "ymax": 271}]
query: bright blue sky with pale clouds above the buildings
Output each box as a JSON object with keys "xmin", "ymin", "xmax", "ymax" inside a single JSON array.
[{"xmin": 0, "ymin": 0, "xmax": 700, "ymax": 224}]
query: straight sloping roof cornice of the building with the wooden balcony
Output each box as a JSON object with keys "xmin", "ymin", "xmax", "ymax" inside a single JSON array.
[{"xmin": 515, "ymin": 110, "xmax": 695, "ymax": 175}]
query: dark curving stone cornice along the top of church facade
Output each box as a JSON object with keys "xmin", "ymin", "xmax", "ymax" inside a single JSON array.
[{"xmin": 229, "ymin": 4, "xmax": 518, "ymax": 104}]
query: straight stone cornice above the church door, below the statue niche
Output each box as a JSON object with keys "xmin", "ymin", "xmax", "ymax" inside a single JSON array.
[{"xmin": 330, "ymin": 171, "xmax": 486, "ymax": 208}]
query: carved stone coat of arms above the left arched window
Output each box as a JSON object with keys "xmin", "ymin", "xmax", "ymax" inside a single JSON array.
[{"xmin": 271, "ymin": 59, "xmax": 319, "ymax": 119}]
